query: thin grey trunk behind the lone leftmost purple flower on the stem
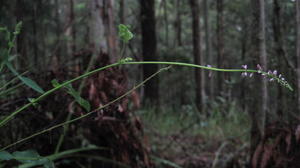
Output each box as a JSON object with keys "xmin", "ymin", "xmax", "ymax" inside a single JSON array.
[{"xmin": 203, "ymin": 0, "xmax": 214, "ymax": 98}]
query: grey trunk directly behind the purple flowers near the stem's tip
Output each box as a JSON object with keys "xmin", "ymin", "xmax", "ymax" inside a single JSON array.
[{"xmin": 250, "ymin": 0, "xmax": 268, "ymax": 166}]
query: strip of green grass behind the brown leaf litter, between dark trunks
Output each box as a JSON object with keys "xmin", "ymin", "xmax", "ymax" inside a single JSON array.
[{"xmin": 138, "ymin": 102, "xmax": 250, "ymax": 141}]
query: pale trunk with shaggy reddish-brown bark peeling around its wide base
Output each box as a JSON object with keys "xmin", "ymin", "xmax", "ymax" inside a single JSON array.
[{"xmin": 83, "ymin": 0, "xmax": 152, "ymax": 168}]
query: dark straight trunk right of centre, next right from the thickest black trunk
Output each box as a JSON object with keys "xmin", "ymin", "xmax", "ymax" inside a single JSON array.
[{"xmin": 190, "ymin": 0, "xmax": 205, "ymax": 112}]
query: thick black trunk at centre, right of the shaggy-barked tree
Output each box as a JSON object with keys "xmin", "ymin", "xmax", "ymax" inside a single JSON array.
[{"xmin": 140, "ymin": 0, "xmax": 159, "ymax": 104}]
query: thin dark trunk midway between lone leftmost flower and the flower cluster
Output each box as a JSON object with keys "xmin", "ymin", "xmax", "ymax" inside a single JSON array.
[{"xmin": 217, "ymin": 0, "xmax": 225, "ymax": 94}]
